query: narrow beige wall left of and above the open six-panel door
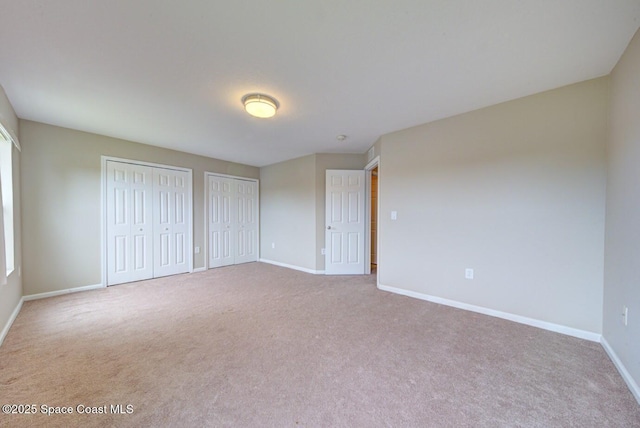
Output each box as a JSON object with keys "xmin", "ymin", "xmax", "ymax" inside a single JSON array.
[{"xmin": 315, "ymin": 153, "xmax": 365, "ymax": 271}]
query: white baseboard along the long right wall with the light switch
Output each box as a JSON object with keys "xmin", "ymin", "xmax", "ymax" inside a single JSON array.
[{"xmin": 378, "ymin": 284, "xmax": 602, "ymax": 342}]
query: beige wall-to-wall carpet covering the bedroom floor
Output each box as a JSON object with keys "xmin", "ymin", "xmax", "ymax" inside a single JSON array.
[{"xmin": 0, "ymin": 263, "xmax": 640, "ymax": 427}]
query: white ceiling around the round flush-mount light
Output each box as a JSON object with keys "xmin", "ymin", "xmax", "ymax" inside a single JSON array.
[{"xmin": 0, "ymin": 0, "xmax": 640, "ymax": 166}]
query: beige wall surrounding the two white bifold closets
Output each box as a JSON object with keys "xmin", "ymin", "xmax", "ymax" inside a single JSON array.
[{"xmin": 20, "ymin": 120, "xmax": 259, "ymax": 295}]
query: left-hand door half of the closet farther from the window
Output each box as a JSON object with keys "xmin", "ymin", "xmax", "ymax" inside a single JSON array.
[{"xmin": 208, "ymin": 175, "xmax": 235, "ymax": 268}]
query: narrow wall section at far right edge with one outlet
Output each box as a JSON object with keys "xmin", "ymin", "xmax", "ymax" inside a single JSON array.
[{"xmin": 603, "ymin": 32, "xmax": 640, "ymax": 392}]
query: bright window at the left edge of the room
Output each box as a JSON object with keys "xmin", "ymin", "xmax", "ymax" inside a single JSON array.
[{"xmin": 0, "ymin": 123, "xmax": 17, "ymax": 284}]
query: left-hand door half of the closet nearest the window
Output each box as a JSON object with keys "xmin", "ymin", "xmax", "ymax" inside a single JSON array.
[{"xmin": 107, "ymin": 162, "xmax": 153, "ymax": 285}]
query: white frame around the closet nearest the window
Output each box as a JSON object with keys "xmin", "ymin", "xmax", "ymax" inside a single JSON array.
[{"xmin": 100, "ymin": 155, "xmax": 194, "ymax": 288}]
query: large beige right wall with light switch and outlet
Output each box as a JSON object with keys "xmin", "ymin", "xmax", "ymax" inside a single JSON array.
[{"xmin": 378, "ymin": 78, "xmax": 608, "ymax": 333}]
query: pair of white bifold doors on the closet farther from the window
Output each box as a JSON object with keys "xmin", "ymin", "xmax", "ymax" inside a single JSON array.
[{"xmin": 208, "ymin": 175, "xmax": 258, "ymax": 268}]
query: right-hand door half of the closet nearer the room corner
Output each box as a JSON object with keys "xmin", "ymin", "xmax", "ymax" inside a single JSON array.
[{"xmin": 234, "ymin": 180, "xmax": 258, "ymax": 264}]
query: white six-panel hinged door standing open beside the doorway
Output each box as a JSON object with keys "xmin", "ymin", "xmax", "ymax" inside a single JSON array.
[{"xmin": 325, "ymin": 169, "xmax": 366, "ymax": 275}]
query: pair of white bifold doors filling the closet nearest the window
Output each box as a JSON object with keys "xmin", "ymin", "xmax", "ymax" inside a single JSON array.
[{"xmin": 105, "ymin": 160, "xmax": 192, "ymax": 285}]
